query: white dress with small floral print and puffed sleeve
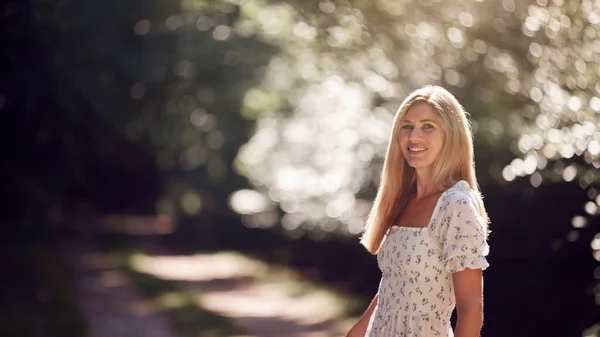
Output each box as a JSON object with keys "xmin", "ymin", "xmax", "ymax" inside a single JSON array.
[{"xmin": 366, "ymin": 181, "xmax": 489, "ymax": 337}]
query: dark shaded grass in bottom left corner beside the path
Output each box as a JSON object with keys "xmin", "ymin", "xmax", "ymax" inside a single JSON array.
[{"xmin": 0, "ymin": 240, "xmax": 86, "ymax": 337}]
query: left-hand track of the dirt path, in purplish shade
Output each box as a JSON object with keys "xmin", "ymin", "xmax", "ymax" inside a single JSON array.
[{"xmin": 62, "ymin": 237, "xmax": 178, "ymax": 337}]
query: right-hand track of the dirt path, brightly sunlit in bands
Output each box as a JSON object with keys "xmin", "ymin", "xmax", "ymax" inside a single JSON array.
[{"xmin": 138, "ymin": 236, "xmax": 352, "ymax": 337}]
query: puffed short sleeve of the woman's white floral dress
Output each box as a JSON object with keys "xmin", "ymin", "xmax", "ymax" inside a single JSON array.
[{"xmin": 437, "ymin": 189, "xmax": 489, "ymax": 273}]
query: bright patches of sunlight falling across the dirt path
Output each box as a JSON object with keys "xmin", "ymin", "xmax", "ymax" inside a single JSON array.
[{"xmin": 130, "ymin": 249, "xmax": 355, "ymax": 325}]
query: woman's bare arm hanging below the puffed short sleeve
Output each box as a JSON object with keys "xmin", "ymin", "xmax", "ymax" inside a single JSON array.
[{"xmin": 452, "ymin": 268, "xmax": 483, "ymax": 337}]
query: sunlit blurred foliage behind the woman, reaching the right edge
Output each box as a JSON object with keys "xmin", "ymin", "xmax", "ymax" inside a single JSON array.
[{"xmin": 237, "ymin": 0, "xmax": 600, "ymax": 234}]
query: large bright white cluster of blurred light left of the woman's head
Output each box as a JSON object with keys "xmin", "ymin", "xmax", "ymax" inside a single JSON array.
[{"xmin": 232, "ymin": 73, "xmax": 376, "ymax": 232}]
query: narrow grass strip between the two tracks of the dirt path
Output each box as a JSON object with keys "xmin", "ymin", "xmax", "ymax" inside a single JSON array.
[{"xmin": 102, "ymin": 232, "xmax": 244, "ymax": 337}]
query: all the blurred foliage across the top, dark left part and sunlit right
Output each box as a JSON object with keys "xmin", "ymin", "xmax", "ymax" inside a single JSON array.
[{"xmin": 29, "ymin": 0, "xmax": 600, "ymax": 249}]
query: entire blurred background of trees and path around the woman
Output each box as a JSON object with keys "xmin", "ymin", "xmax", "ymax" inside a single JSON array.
[{"xmin": 0, "ymin": 0, "xmax": 600, "ymax": 337}]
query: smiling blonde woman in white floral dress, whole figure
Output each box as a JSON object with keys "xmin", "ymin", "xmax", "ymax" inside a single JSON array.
[{"xmin": 348, "ymin": 86, "xmax": 489, "ymax": 337}]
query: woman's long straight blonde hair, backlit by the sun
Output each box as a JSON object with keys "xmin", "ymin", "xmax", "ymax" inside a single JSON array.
[{"xmin": 361, "ymin": 86, "xmax": 489, "ymax": 254}]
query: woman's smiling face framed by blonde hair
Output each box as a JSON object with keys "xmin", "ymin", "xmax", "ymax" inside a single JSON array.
[{"xmin": 400, "ymin": 103, "xmax": 446, "ymax": 170}]
